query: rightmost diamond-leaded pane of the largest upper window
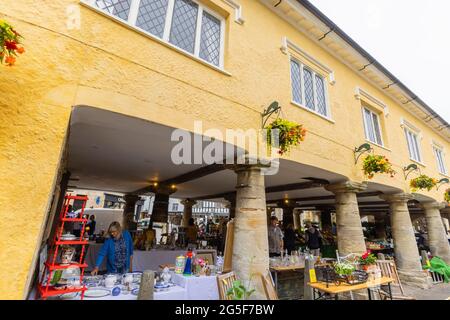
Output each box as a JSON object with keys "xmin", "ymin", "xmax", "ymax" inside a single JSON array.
[{"xmin": 200, "ymin": 11, "xmax": 221, "ymax": 66}]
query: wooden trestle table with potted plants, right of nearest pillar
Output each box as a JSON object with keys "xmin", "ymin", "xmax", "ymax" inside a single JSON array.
[{"xmin": 308, "ymin": 277, "xmax": 394, "ymax": 300}]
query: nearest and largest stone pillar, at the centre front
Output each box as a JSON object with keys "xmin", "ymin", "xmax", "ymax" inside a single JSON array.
[{"xmin": 232, "ymin": 165, "xmax": 269, "ymax": 300}]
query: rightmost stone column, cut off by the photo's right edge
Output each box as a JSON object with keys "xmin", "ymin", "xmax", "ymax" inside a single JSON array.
[{"xmin": 422, "ymin": 202, "xmax": 450, "ymax": 264}]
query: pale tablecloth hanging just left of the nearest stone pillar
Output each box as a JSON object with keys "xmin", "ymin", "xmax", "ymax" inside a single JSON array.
[{"xmin": 172, "ymin": 273, "xmax": 219, "ymax": 300}]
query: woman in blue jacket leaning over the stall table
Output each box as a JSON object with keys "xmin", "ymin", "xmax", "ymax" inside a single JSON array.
[{"xmin": 91, "ymin": 221, "xmax": 133, "ymax": 275}]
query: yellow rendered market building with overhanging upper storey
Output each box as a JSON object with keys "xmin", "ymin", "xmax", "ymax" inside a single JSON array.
[{"xmin": 0, "ymin": 0, "xmax": 450, "ymax": 299}]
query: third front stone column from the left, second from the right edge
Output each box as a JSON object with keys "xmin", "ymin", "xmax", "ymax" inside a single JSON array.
[{"xmin": 381, "ymin": 193, "xmax": 430, "ymax": 289}]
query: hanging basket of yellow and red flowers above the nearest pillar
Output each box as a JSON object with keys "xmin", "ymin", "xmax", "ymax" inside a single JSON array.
[{"xmin": 265, "ymin": 119, "xmax": 306, "ymax": 155}]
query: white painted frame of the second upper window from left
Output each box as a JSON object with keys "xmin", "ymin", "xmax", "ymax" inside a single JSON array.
[{"xmin": 288, "ymin": 54, "xmax": 334, "ymax": 122}]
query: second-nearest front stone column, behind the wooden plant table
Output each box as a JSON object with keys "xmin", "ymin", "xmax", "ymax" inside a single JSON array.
[{"xmin": 325, "ymin": 181, "xmax": 367, "ymax": 256}]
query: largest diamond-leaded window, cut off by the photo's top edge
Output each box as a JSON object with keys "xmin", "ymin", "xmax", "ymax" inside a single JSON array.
[{"xmin": 86, "ymin": 0, "xmax": 225, "ymax": 68}]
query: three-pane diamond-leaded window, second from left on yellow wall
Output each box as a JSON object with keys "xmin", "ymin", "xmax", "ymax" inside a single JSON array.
[{"xmin": 291, "ymin": 59, "xmax": 328, "ymax": 117}]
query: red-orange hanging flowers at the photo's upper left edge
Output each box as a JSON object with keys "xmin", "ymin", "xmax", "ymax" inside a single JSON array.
[{"xmin": 0, "ymin": 19, "xmax": 25, "ymax": 66}]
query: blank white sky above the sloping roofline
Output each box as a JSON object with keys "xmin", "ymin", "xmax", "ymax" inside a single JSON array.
[{"xmin": 310, "ymin": 0, "xmax": 450, "ymax": 122}]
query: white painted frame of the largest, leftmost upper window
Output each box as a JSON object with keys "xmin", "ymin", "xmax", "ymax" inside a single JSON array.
[{"xmin": 80, "ymin": 0, "xmax": 225, "ymax": 69}]
